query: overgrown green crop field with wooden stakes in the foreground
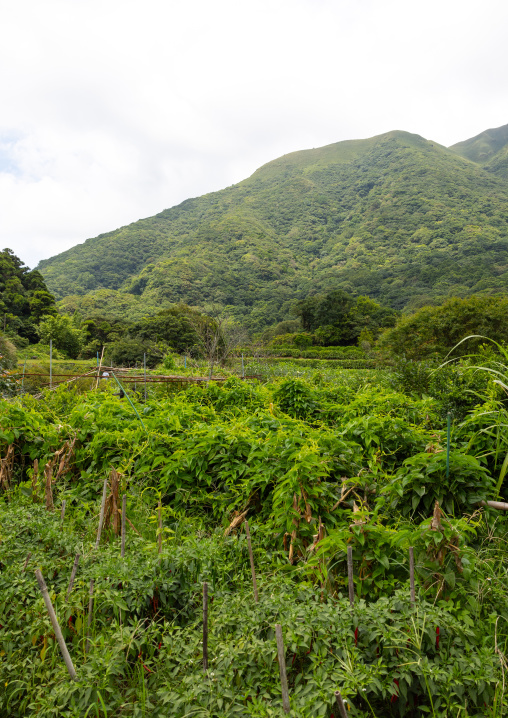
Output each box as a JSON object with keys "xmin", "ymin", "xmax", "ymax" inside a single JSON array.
[{"xmin": 0, "ymin": 359, "xmax": 508, "ymax": 718}]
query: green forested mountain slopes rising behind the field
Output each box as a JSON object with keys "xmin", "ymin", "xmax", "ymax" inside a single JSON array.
[{"xmin": 38, "ymin": 128, "xmax": 508, "ymax": 330}]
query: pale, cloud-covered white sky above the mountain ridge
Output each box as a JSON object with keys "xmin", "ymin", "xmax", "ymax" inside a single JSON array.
[{"xmin": 0, "ymin": 0, "xmax": 508, "ymax": 268}]
